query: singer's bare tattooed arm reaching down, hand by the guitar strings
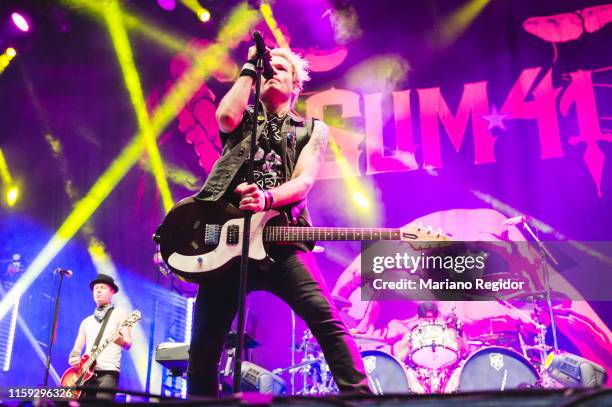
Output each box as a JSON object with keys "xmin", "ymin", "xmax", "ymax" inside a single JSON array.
[{"xmin": 236, "ymin": 120, "xmax": 329, "ymax": 211}]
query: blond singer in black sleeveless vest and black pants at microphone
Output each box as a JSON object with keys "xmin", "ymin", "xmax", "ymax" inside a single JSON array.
[{"xmin": 187, "ymin": 40, "xmax": 370, "ymax": 396}]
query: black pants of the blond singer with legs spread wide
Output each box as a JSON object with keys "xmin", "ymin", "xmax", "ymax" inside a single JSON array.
[{"xmin": 187, "ymin": 250, "xmax": 370, "ymax": 396}]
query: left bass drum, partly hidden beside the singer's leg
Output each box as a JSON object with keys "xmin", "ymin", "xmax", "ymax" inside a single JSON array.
[{"xmin": 361, "ymin": 350, "xmax": 425, "ymax": 394}]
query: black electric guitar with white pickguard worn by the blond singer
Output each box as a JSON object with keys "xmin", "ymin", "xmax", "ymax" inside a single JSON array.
[{"xmin": 156, "ymin": 197, "xmax": 450, "ymax": 282}]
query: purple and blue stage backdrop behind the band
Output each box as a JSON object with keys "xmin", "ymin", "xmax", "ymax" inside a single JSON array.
[{"xmin": 0, "ymin": 0, "xmax": 612, "ymax": 392}]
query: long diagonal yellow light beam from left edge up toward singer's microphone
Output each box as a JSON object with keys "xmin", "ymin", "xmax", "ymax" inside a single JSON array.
[{"xmin": 0, "ymin": 3, "xmax": 259, "ymax": 319}]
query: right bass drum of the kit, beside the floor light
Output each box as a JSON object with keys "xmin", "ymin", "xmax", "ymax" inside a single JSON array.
[{"xmin": 444, "ymin": 346, "xmax": 540, "ymax": 393}]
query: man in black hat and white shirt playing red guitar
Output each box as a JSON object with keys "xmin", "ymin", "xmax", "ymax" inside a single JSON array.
[{"xmin": 62, "ymin": 274, "xmax": 132, "ymax": 400}]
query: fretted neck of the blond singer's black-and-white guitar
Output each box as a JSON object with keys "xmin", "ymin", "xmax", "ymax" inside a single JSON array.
[{"xmin": 264, "ymin": 226, "xmax": 402, "ymax": 242}]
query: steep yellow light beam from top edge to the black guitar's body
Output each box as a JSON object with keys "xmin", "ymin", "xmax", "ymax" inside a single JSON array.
[{"xmin": 105, "ymin": 0, "xmax": 174, "ymax": 212}]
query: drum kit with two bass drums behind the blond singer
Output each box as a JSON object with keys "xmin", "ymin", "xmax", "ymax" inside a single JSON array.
[{"xmin": 273, "ymin": 299, "xmax": 558, "ymax": 395}]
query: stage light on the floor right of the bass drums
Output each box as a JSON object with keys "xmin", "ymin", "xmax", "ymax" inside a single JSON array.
[{"xmin": 544, "ymin": 352, "xmax": 608, "ymax": 387}]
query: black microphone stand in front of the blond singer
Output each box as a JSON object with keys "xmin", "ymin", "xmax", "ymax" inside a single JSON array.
[{"xmin": 232, "ymin": 49, "xmax": 265, "ymax": 393}]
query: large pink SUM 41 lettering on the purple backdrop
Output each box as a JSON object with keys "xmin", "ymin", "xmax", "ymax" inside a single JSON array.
[{"xmin": 306, "ymin": 67, "xmax": 612, "ymax": 196}]
